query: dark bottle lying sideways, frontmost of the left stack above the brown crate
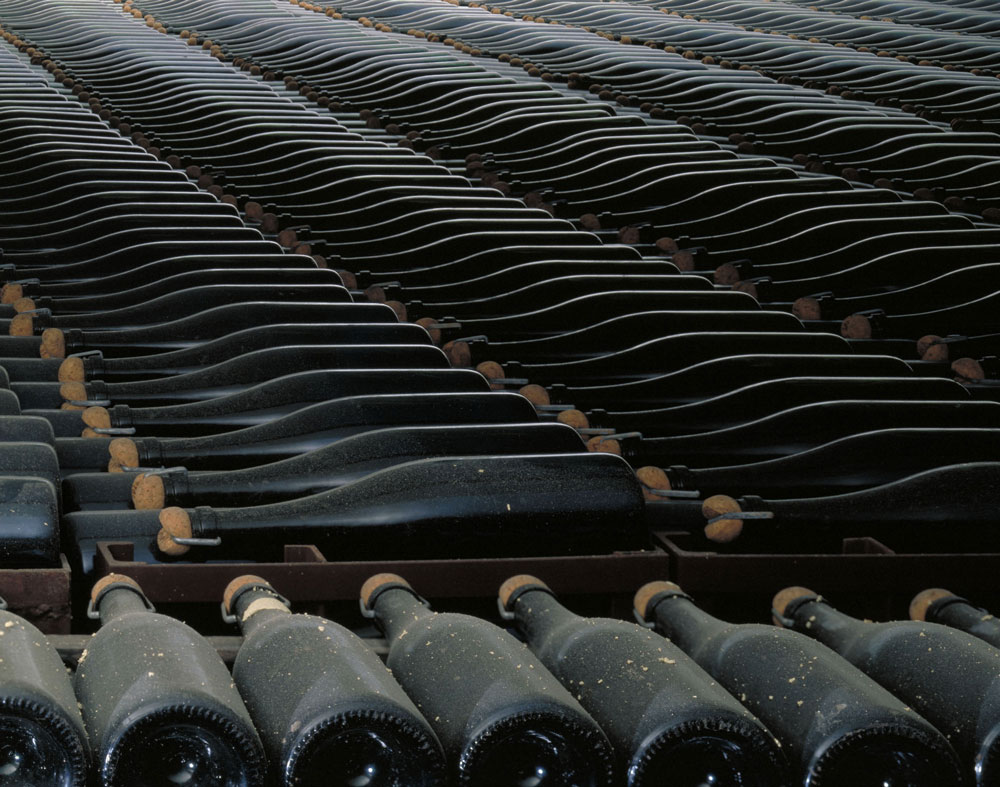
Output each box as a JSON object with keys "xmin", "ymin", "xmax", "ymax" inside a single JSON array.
[{"xmin": 64, "ymin": 453, "xmax": 646, "ymax": 561}]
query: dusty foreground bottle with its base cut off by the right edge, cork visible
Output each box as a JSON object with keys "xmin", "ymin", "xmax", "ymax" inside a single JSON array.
[{"xmin": 773, "ymin": 587, "xmax": 1000, "ymax": 785}]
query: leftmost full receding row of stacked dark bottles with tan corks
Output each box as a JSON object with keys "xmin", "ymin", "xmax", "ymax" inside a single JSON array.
[{"xmin": 0, "ymin": 29, "xmax": 644, "ymax": 570}]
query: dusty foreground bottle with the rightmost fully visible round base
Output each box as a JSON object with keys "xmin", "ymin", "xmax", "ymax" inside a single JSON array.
[{"xmin": 635, "ymin": 582, "xmax": 963, "ymax": 787}]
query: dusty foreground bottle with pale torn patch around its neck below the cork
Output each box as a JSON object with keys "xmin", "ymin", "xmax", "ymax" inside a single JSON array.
[{"xmin": 229, "ymin": 576, "xmax": 445, "ymax": 787}]
